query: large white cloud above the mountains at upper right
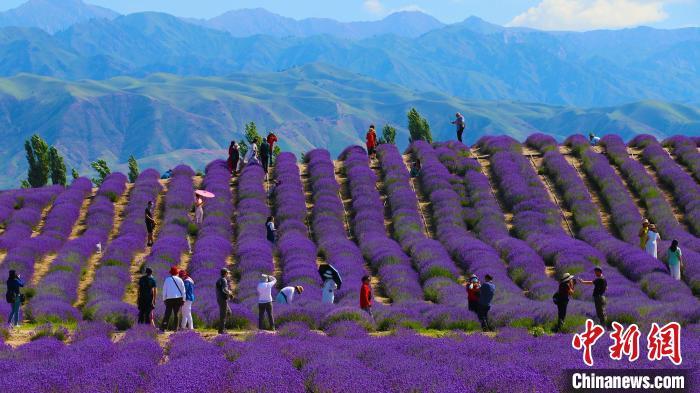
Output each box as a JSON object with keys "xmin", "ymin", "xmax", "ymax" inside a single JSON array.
[{"xmin": 508, "ymin": 0, "xmax": 669, "ymax": 30}]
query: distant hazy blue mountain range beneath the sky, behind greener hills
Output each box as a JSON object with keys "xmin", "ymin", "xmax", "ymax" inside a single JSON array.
[{"xmin": 0, "ymin": 9, "xmax": 700, "ymax": 107}]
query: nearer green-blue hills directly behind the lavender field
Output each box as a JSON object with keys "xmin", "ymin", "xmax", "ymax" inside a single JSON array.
[{"xmin": 0, "ymin": 64, "xmax": 700, "ymax": 188}]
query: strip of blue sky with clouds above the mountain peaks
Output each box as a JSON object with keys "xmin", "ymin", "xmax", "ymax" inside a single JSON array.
[{"xmin": 0, "ymin": 0, "xmax": 700, "ymax": 30}]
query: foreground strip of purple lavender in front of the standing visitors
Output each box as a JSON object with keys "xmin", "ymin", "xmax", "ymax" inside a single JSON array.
[{"xmin": 0, "ymin": 322, "xmax": 700, "ymax": 393}]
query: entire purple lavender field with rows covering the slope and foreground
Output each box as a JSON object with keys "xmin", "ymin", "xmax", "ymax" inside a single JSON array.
[{"xmin": 0, "ymin": 134, "xmax": 700, "ymax": 393}]
